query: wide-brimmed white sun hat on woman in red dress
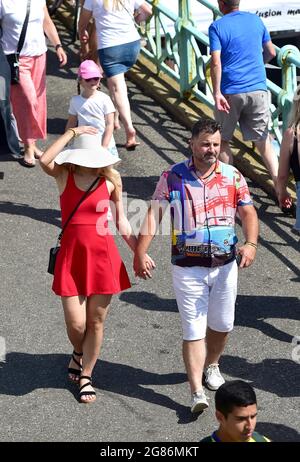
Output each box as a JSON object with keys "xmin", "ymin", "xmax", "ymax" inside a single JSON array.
[{"xmin": 54, "ymin": 133, "xmax": 121, "ymax": 168}]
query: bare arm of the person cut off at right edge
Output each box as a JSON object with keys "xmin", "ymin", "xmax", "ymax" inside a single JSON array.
[{"xmin": 277, "ymin": 128, "xmax": 294, "ymax": 206}]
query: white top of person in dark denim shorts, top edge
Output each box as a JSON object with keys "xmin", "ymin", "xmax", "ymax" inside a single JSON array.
[{"xmin": 83, "ymin": 0, "xmax": 144, "ymax": 49}]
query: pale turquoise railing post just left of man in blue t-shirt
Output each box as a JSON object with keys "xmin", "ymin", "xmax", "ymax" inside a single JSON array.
[{"xmin": 175, "ymin": 0, "xmax": 196, "ymax": 98}]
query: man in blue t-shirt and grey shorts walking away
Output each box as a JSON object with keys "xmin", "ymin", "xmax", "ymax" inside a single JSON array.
[{"xmin": 209, "ymin": 0, "xmax": 278, "ymax": 187}]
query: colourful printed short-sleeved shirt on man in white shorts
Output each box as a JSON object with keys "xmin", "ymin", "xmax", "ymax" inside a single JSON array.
[{"xmin": 152, "ymin": 157, "xmax": 252, "ymax": 267}]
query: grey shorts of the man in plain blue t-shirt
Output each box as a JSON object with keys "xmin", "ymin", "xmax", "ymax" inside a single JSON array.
[{"xmin": 215, "ymin": 91, "xmax": 270, "ymax": 141}]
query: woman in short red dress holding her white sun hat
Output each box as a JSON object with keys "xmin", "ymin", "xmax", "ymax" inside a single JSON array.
[{"xmin": 40, "ymin": 126, "xmax": 154, "ymax": 403}]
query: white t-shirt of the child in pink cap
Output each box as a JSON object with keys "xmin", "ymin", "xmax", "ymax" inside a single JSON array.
[{"xmin": 69, "ymin": 91, "xmax": 116, "ymax": 148}]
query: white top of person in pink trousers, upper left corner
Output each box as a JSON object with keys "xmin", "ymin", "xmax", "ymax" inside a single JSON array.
[{"xmin": 0, "ymin": 0, "xmax": 47, "ymax": 56}]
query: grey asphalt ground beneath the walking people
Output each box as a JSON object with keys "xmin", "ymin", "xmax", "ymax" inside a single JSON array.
[{"xmin": 0, "ymin": 26, "xmax": 300, "ymax": 443}]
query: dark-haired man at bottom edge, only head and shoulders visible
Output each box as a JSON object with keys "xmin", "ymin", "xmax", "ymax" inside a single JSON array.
[{"xmin": 200, "ymin": 380, "xmax": 270, "ymax": 443}]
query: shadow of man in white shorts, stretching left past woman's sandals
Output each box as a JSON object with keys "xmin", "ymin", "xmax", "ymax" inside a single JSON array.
[{"xmin": 0, "ymin": 352, "xmax": 198, "ymax": 423}]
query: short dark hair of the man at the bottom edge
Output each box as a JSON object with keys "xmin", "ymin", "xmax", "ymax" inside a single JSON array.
[{"xmin": 215, "ymin": 380, "xmax": 256, "ymax": 417}]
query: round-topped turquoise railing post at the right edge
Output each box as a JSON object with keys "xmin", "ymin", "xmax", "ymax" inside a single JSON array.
[{"xmin": 277, "ymin": 45, "xmax": 300, "ymax": 133}]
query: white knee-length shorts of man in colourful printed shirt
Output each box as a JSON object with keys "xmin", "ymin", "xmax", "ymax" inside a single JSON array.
[{"xmin": 172, "ymin": 260, "xmax": 238, "ymax": 340}]
